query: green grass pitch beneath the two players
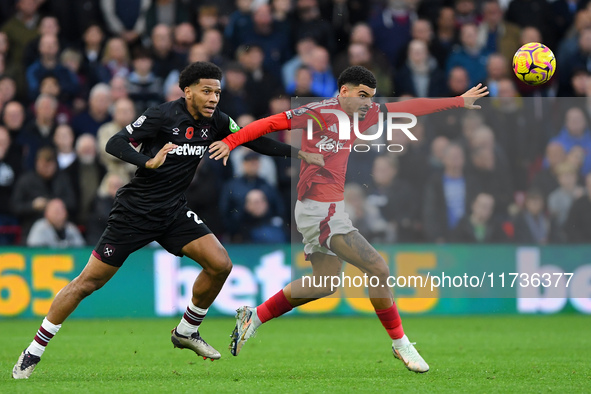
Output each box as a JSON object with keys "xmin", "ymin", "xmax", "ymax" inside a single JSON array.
[{"xmin": 0, "ymin": 315, "xmax": 591, "ymax": 393}]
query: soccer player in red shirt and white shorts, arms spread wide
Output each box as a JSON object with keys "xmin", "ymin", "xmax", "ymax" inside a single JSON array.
[{"xmin": 210, "ymin": 66, "xmax": 488, "ymax": 372}]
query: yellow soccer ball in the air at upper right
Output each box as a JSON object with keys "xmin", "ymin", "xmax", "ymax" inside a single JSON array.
[{"xmin": 513, "ymin": 42, "xmax": 556, "ymax": 85}]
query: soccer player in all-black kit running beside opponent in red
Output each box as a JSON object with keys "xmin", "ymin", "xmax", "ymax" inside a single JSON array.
[{"xmin": 12, "ymin": 62, "xmax": 323, "ymax": 379}]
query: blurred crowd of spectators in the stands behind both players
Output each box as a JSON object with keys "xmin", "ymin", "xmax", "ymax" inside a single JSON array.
[{"xmin": 0, "ymin": 0, "xmax": 591, "ymax": 246}]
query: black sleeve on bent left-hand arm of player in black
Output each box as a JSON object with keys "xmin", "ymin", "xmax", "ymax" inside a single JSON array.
[{"xmin": 105, "ymin": 107, "xmax": 162, "ymax": 167}]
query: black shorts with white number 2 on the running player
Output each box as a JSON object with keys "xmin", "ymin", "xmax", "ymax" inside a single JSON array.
[{"xmin": 92, "ymin": 202, "xmax": 211, "ymax": 267}]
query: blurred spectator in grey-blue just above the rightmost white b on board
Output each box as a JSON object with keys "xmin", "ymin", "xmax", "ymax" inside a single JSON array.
[{"xmin": 513, "ymin": 190, "xmax": 552, "ymax": 245}]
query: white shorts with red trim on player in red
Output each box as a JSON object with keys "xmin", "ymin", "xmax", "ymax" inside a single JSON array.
[{"xmin": 295, "ymin": 199, "xmax": 357, "ymax": 259}]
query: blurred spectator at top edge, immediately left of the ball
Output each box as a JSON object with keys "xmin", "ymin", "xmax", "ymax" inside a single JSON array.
[{"xmin": 478, "ymin": 0, "xmax": 521, "ymax": 62}]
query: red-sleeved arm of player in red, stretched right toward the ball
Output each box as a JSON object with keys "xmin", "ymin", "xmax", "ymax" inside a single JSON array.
[{"xmin": 385, "ymin": 84, "xmax": 489, "ymax": 116}]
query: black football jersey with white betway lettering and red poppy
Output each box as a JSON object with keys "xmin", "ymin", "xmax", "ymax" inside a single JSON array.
[{"xmin": 106, "ymin": 98, "xmax": 297, "ymax": 219}]
